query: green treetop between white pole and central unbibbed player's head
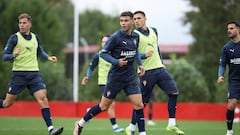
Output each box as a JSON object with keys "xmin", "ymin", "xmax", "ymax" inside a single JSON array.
[{"xmin": 79, "ymin": 10, "xmax": 120, "ymax": 44}]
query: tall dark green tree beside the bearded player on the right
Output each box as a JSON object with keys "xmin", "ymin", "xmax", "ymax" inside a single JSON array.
[{"xmin": 184, "ymin": 0, "xmax": 240, "ymax": 101}]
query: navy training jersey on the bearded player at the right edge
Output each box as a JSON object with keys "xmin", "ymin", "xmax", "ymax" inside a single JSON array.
[{"xmin": 218, "ymin": 40, "xmax": 240, "ymax": 80}]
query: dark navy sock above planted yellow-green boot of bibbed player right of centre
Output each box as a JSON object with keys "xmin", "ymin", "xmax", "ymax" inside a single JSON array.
[{"xmin": 168, "ymin": 95, "xmax": 177, "ymax": 118}]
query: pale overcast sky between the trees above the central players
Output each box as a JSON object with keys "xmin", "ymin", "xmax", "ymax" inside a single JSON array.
[{"xmin": 72, "ymin": 0, "xmax": 193, "ymax": 44}]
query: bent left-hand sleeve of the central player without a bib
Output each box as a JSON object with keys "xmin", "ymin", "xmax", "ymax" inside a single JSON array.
[{"xmin": 100, "ymin": 37, "xmax": 119, "ymax": 65}]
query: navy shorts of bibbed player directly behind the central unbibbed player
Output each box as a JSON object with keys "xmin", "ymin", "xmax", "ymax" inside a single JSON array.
[{"xmin": 140, "ymin": 68, "xmax": 178, "ymax": 103}]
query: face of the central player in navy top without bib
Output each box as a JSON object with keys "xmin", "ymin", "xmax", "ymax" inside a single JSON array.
[{"xmin": 120, "ymin": 16, "xmax": 133, "ymax": 34}]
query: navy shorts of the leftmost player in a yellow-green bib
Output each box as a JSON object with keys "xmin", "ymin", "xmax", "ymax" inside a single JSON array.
[{"xmin": 8, "ymin": 71, "xmax": 46, "ymax": 95}]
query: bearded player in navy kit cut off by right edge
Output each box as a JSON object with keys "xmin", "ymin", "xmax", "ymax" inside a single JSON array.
[{"xmin": 217, "ymin": 21, "xmax": 240, "ymax": 135}]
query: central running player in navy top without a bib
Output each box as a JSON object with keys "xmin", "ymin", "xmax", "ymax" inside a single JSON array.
[{"xmin": 74, "ymin": 11, "xmax": 146, "ymax": 135}]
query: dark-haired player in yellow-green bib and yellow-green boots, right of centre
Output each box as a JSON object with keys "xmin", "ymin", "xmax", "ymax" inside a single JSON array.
[{"xmin": 126, "ymin": 11, "xmax": 184, "ymax": 135}]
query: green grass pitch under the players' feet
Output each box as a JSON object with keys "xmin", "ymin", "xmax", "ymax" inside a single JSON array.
[{"xmin": 0, "ymin": 117, "xmax": 240, "ymax": 135}]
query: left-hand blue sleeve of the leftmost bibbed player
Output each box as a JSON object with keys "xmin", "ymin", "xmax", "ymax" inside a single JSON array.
[{"xmin": 2, "ymin": 34, "xmax": 17, "ymax": 61}]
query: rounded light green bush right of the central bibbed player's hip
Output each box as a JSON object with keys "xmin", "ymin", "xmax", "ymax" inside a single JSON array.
[{"xmin": 164, "ymin": 55, "xmax": 210, "ymax": 102}]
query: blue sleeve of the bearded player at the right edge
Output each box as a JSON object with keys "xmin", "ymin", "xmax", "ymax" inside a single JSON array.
[{"xmin": 218, "ymin": 47, "xmax": 227, "ymax": 77}]
